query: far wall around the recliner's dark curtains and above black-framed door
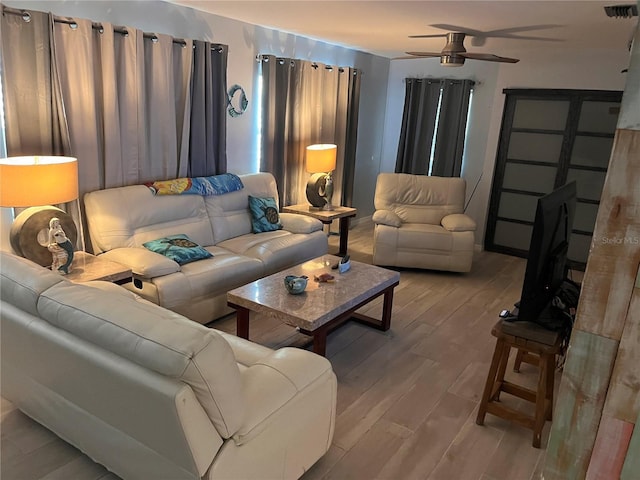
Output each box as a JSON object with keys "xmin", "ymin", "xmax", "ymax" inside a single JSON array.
[{"xmin": 381, "ymin": 47, "xmax": 629, "ymax": 245}]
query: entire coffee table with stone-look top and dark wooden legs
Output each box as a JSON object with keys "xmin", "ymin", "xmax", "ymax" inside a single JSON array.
[{"xmin": 227, "ymin": 255, "xmax": 400, "ymax": 355}]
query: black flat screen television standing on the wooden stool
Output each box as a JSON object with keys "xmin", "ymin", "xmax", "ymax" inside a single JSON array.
[{"xmin": 517, "ymin": 182, "xmax": 576, "ymax": 322}]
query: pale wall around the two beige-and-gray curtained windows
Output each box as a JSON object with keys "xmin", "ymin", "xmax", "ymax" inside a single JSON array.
[{"xmin": 3, "ymin": 0, "xmax": 390, "ymax": 220}]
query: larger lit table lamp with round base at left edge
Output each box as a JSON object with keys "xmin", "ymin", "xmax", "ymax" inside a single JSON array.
[{"xmin": 0, "ymin": 156, "xmax": 78, "ymax": 273}]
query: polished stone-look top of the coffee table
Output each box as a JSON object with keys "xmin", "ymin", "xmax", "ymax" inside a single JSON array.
[{"xmin": 227, "ymin": 255, "xmax": 400, "ymax": 331}]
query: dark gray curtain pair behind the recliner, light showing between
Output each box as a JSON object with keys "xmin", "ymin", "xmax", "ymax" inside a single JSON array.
[{"xmin": 395, "ymin": 78, "xmax": 474, "ymax": 177}]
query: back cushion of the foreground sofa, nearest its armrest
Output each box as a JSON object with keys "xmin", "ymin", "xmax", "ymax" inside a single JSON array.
[{"xmin": 38, "ymin": 282, "xmax": 245, "ymax": 438}]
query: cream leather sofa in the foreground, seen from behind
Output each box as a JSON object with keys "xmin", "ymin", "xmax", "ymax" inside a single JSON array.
[{"xmin": 0, "ymin": 252, "xmax": 336, "ymax": 480}]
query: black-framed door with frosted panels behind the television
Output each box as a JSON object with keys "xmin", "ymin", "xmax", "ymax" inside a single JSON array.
[{"xmin": 485, "ymin": 89, "xmax": 622, "ymax": 268}]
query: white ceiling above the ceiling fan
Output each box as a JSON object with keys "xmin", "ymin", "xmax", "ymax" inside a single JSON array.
[{"xmin": 168, "ymin": 0, "xmax": 638, "ymax": 58}]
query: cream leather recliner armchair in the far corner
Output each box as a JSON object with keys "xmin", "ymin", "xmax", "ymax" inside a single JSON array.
[{"xmin": 372, "ymin": 173, "xmax": 476, "ymax": 272}]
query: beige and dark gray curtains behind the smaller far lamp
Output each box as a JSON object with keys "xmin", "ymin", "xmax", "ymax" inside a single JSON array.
[{"xmin": 259, "ymin": 55, "xmax": 360, "ymax": 206}]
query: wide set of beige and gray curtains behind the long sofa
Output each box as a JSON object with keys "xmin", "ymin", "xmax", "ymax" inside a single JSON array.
[{"xmin": 0, "ymin": 5, "xmax": 227, "ymax": 251}]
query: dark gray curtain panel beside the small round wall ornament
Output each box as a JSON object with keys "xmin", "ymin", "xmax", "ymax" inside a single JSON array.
[{"xmin": 189, "ymin": 40, "xmax": 229, "ymax": 177}]
